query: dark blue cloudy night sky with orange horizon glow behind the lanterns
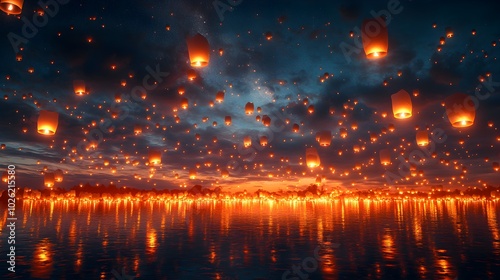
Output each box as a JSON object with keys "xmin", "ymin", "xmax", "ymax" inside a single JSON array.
[{"xmin": 0, "ymin": 0, "xmax": 500, "ymax": 191}]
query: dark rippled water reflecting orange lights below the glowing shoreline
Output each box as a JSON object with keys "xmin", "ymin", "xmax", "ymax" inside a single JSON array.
[{"xmin": 0, "ymin": 201, "xmax": 500, "ymax": 280}]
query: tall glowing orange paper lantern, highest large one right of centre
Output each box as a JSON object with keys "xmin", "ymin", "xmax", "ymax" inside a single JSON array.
[{"xmin": 361, "ymin": 17, "xmax": 389, "ymax": 59}]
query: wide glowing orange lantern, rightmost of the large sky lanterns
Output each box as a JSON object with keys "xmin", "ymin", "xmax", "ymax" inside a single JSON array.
[{"xmin": 445, "ymin": 93, "xmax": 476, "ymax": 127}]
